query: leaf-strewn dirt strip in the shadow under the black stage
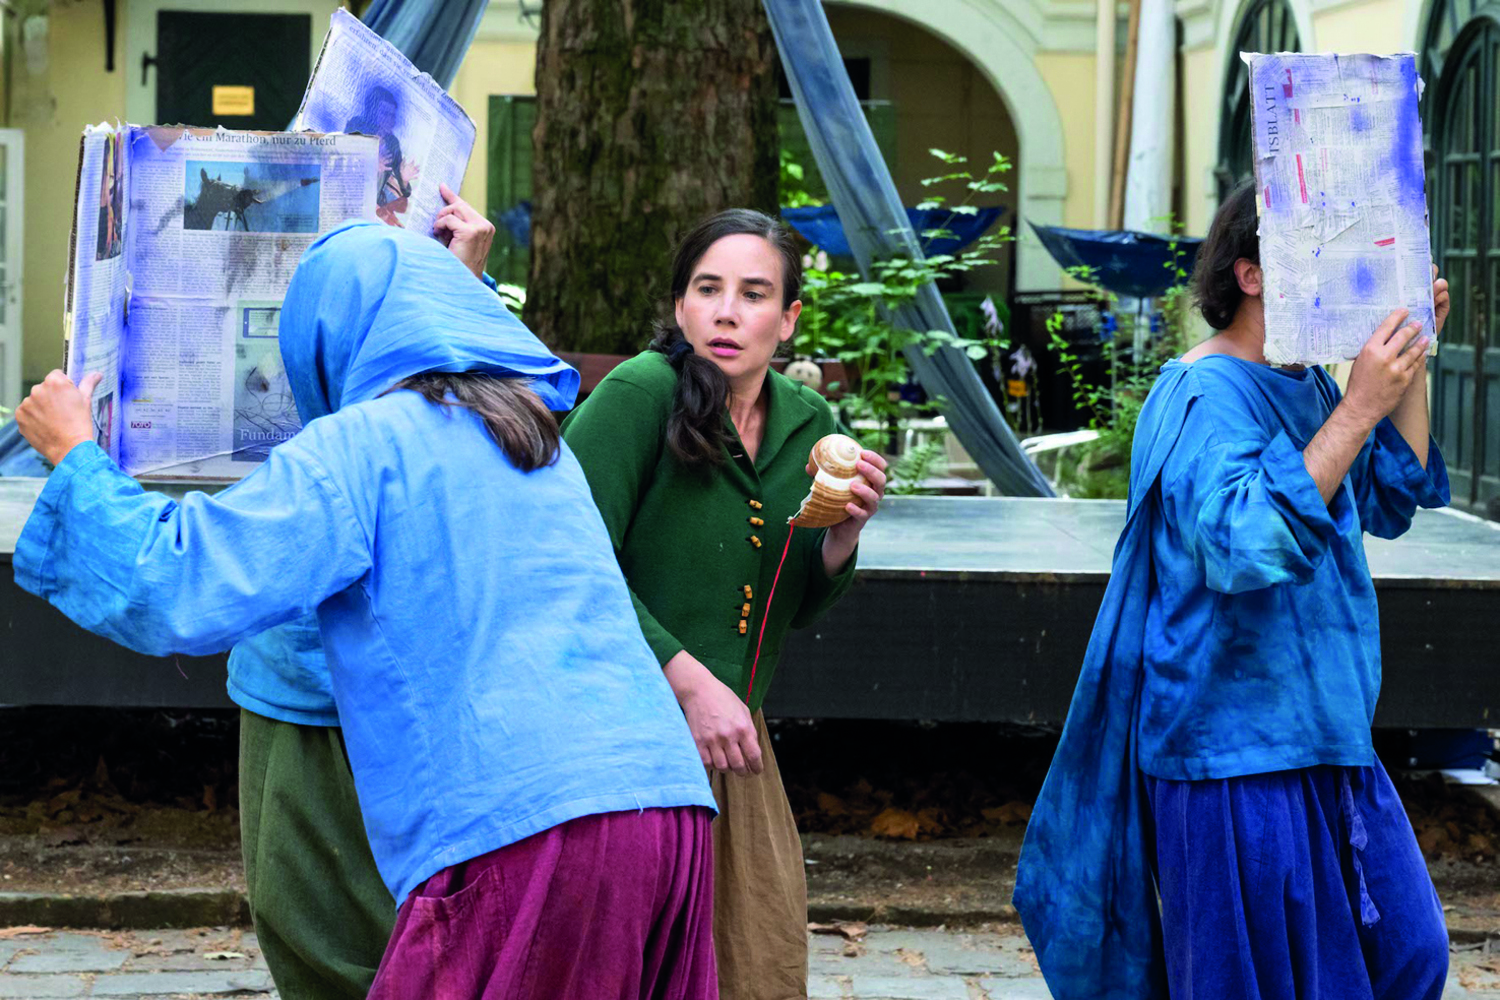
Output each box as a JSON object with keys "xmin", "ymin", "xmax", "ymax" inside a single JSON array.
[{"xmin": 0, "ymin": 709, "xmax": 1500, "ymax": 936}]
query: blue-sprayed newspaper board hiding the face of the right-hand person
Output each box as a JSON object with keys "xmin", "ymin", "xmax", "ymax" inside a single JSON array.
[{"xmin": 1241, "ymin": 52, "xmax": 1437, "ymax": 364}]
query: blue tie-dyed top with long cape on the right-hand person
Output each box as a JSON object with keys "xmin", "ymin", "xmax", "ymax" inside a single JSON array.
[{"xmin": 1016, "ymin": 355, "xmax": 1448, "ymax": 1000}]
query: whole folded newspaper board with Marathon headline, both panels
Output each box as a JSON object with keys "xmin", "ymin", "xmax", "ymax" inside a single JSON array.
[{"xmin": 63, "ymin": 126, "xmax": 380, "ymax": 481}]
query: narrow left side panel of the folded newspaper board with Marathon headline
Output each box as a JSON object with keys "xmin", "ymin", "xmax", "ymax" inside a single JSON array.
[{"xmin": 63, "ymin": 124, "xmax": 131, "ymax": 460}]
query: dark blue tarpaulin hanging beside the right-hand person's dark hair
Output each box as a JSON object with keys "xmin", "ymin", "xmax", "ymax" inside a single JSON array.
[{"xmin": 1032, "ymin": 222, "xmax": 1203, "ymax": 298}]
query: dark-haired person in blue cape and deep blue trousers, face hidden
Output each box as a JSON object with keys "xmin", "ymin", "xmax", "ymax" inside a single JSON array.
[{"xmin": 1016, "ymin": 184, "xmax": 1449, "ymax": 1000}]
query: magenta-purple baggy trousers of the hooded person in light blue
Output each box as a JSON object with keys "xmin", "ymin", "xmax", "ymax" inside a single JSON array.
[{"xmin": 369, "ymin": 807, "xmax": 719, "ymax": 1000}]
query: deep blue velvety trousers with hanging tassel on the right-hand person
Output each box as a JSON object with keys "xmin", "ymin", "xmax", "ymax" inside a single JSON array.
[{"xmin": 1148, "ymin": 760, "xmax": 1448, "ymax": 1000}]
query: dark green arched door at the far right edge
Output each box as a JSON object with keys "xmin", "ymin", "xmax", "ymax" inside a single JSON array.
[{"xmin": 1424, "ymin": 13, "xmax": 1500, "ymax": 510}]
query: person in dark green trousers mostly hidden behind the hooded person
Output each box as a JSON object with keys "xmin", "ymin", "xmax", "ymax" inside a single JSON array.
[{"xmin": 228, "ymin": 184, "xmax": 495, "ymax": 1000}]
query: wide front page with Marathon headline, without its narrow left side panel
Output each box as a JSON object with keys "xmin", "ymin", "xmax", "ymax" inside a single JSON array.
[{"xmin": 120, "ymin": 126, "xmax": 378, "ymax": 481}]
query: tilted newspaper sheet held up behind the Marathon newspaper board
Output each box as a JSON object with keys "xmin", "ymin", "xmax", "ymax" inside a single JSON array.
[{"xmin": 291, "ymin": 9, "xmax": 474, "ymax": 234}]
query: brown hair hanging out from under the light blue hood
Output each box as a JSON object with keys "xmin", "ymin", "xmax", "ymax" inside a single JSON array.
[{"xmin": 387, "ymin": 372, "xmax": 561, "ymax": 472}]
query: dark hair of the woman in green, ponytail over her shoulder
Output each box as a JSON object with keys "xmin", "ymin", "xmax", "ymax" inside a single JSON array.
[{"xmin": 650, "ymin": 208, "xmax": 803, "ymax": 468}]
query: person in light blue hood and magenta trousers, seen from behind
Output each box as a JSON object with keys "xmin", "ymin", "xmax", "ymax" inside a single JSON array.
[{"xmin": 15, "ymin": 222, "xmax": 716, "ymax": 999}]
